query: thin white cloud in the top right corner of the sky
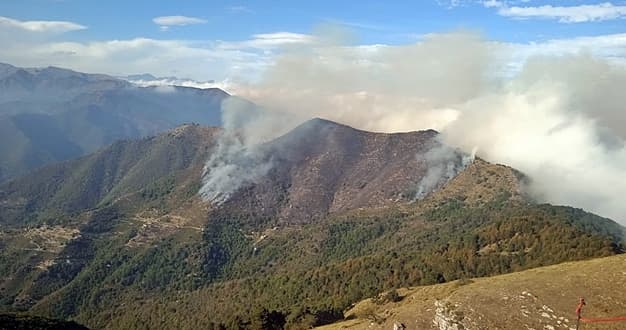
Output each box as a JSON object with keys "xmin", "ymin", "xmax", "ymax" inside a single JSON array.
[{"xmin": 500, "ymin": 1, "xmax": 626, "ymax": 23}]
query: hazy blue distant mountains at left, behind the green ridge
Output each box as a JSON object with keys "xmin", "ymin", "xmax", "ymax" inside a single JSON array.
[{"xmin": 0, "ymin": 64, "xmax": 228, "ymax": 181}]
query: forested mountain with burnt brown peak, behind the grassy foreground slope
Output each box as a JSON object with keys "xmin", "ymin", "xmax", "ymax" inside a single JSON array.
[{"xmin": 0, "ymin": 117, "xmax": 623, "ymax": 329}]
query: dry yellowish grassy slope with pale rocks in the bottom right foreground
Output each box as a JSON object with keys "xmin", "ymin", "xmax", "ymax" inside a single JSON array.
[{"xmin": 319, "ymin": 255, "xmax": 626, "ymax": 330}]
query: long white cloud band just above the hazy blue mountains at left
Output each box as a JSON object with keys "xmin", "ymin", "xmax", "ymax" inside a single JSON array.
[{"xmin": 0, "ymin": 38, "xmax": 270, "ymax": 80}]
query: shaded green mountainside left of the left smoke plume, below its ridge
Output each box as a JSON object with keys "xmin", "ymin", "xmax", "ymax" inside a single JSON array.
[{"xmin": 0, "ymin": 125, "xmax": 218, "ymax": 225}]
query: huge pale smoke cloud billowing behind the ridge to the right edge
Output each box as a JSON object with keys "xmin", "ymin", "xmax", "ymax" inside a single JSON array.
[{"xmin": 204, "ymin": 33, "xmax": 626, "ymax": 223}]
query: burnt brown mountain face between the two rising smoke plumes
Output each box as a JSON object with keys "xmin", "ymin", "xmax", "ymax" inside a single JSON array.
[{"xmin": 214, "ymin": 119, "xmax": 439, "ymax": 223}]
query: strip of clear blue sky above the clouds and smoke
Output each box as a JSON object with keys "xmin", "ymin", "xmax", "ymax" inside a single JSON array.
[{"xmin": 0, "ymin": 0, "xmax": 626, "ymax": 43}]
